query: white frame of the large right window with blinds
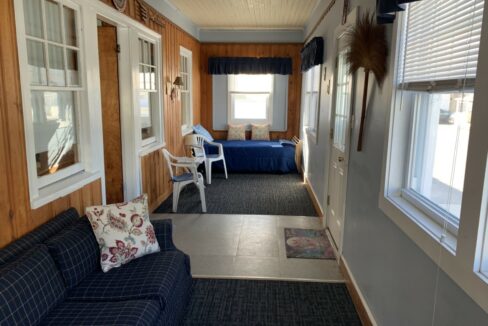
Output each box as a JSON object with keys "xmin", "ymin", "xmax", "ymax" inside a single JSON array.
[{"xmin": 378, "ymin": 5, "xmax": 488, "ymax": 312}]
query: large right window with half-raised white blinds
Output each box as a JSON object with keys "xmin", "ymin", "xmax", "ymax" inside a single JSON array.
[{"xmin": 386, "ymin": 0, "xmax": 483, "ymax": 251}]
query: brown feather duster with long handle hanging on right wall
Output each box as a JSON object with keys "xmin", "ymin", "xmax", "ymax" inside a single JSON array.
[{"xmin": 346, "ymin": 12, "xmax": 388, "ymax": 151}]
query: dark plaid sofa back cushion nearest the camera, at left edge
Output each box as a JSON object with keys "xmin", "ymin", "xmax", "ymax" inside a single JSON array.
[{"xmin": 0, "ymin": 245, "xmax": 66, "ymax": 325}]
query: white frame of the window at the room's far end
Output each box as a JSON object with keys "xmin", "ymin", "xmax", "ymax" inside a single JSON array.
[{"xmin": 227, "ymin": 75, "xmax": 275, "ymax": 129}]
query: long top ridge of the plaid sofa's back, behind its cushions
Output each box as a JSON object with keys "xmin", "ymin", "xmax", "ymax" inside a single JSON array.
[{"xmin": 0, "ymin": 208, "xmax": 80, "ymax": 265}]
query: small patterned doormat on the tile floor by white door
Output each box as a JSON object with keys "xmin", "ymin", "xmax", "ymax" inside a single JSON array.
[{"xmin": 285, "ymin": 228, "xmax": 335, "ymax": 259}]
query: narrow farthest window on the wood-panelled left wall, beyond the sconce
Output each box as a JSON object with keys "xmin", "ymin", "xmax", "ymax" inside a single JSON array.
[{"xmin": 180, "ymin": 47, "xmax": 193, "ymax": 134}]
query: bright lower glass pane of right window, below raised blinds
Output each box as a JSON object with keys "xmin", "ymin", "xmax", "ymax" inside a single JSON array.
[{"xmin": 410, "ymin": 93, "xmax": 473, "ymax": 219}]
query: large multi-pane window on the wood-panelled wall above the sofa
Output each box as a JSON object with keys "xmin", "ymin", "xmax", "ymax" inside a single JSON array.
[{"xmin": 15, "ymin": 0, "xmax": 101, "ymax": 208}]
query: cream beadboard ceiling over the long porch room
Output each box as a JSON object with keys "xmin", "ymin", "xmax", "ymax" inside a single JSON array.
[{"xmin": 165, "ymin": 0, "xmax": 319, "ymax": 29}]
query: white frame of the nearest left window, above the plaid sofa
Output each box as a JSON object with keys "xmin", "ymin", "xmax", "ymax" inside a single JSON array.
[{"xmin": 14, "ymin": 0, "xmax": 103, "ymax": 209}]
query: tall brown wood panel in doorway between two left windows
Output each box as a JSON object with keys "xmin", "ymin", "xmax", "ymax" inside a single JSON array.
[{"xmin": 97, "ymin": 20, "xmax": 124, "ymax": 204}]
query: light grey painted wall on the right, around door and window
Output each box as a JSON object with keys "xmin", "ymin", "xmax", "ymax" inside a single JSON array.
[{"xmin": 306, "ymin": 0, "xmax": 488, "ymax": 326}]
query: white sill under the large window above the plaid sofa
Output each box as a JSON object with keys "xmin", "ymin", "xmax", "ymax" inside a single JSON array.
[{"xmin": 31, "ymin": 171, "xmax": 101, "ymax": 209}]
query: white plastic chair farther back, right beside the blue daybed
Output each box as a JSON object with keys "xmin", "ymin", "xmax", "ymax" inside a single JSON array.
[{"xmin": 185, "ymin": 134, "xmax": 228, "ymax": 184}]
